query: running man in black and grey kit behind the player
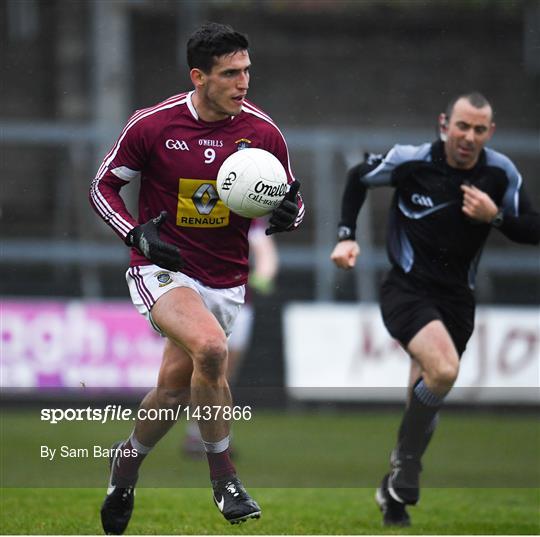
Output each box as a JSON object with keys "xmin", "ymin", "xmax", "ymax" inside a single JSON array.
[{"xmin": 331, "ymin": 92, "xmax": 540, "ymax": 526}]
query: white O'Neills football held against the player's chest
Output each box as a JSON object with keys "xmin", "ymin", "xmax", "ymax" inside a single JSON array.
[{"xmin": 216, "ymin": 147, "xmax": 287, "ymax": 218}]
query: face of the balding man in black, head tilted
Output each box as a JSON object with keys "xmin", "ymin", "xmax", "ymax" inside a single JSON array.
[{"xmin": 444, "ymin": 99, "xmax": 495, "ymax": 170}]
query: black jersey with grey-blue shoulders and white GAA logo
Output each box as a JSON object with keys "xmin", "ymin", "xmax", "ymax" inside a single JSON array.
[{"xmin": 340, "ymin": 141, "xmax": 540, "ymax": 289}]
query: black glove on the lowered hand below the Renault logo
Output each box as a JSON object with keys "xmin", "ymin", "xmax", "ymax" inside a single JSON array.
[{"xmin": 126, "ymin": 211, "xmax": 184, "ymax": 272}]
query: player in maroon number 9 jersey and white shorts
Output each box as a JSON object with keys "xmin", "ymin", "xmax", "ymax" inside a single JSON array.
[{"xmin": 90, "ymin": 23, "xmax": 304, "ymax": 534}]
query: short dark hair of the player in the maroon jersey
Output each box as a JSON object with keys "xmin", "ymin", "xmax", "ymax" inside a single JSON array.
[{"xmin": 187, "ymin": 22, "xmax": 249, "ymax": 73}]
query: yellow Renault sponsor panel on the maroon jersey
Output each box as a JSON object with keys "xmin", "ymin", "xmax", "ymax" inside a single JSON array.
[{"xmin": 176, "ymin": 177, "xmax": 230, "ymax": 228}]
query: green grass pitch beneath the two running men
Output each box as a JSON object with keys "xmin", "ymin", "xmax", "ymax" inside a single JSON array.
[{"xmin": 0, "ymin": 410, "xmax": 540, "ymax": 535}]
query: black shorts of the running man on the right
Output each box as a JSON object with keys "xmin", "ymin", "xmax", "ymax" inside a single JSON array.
[{"xmin": 380, "ymin": 269, "xmax": 475, "ymax": 356}]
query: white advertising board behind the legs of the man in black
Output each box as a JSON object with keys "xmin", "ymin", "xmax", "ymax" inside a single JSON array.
[{"xmin": 283, "ymin": 303, "xmax": 540, "ymax": 404}]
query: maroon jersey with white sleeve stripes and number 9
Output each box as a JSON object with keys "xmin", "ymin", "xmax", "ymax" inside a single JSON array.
[{"xmin": 90, "ymin": 92, "xmax": 304, "ymax": 288}]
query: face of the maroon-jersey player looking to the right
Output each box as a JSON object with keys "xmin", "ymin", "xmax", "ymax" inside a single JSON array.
[{"xmin": 197, "ymin": 50, "xmax": 251, "ymax": 121}]
